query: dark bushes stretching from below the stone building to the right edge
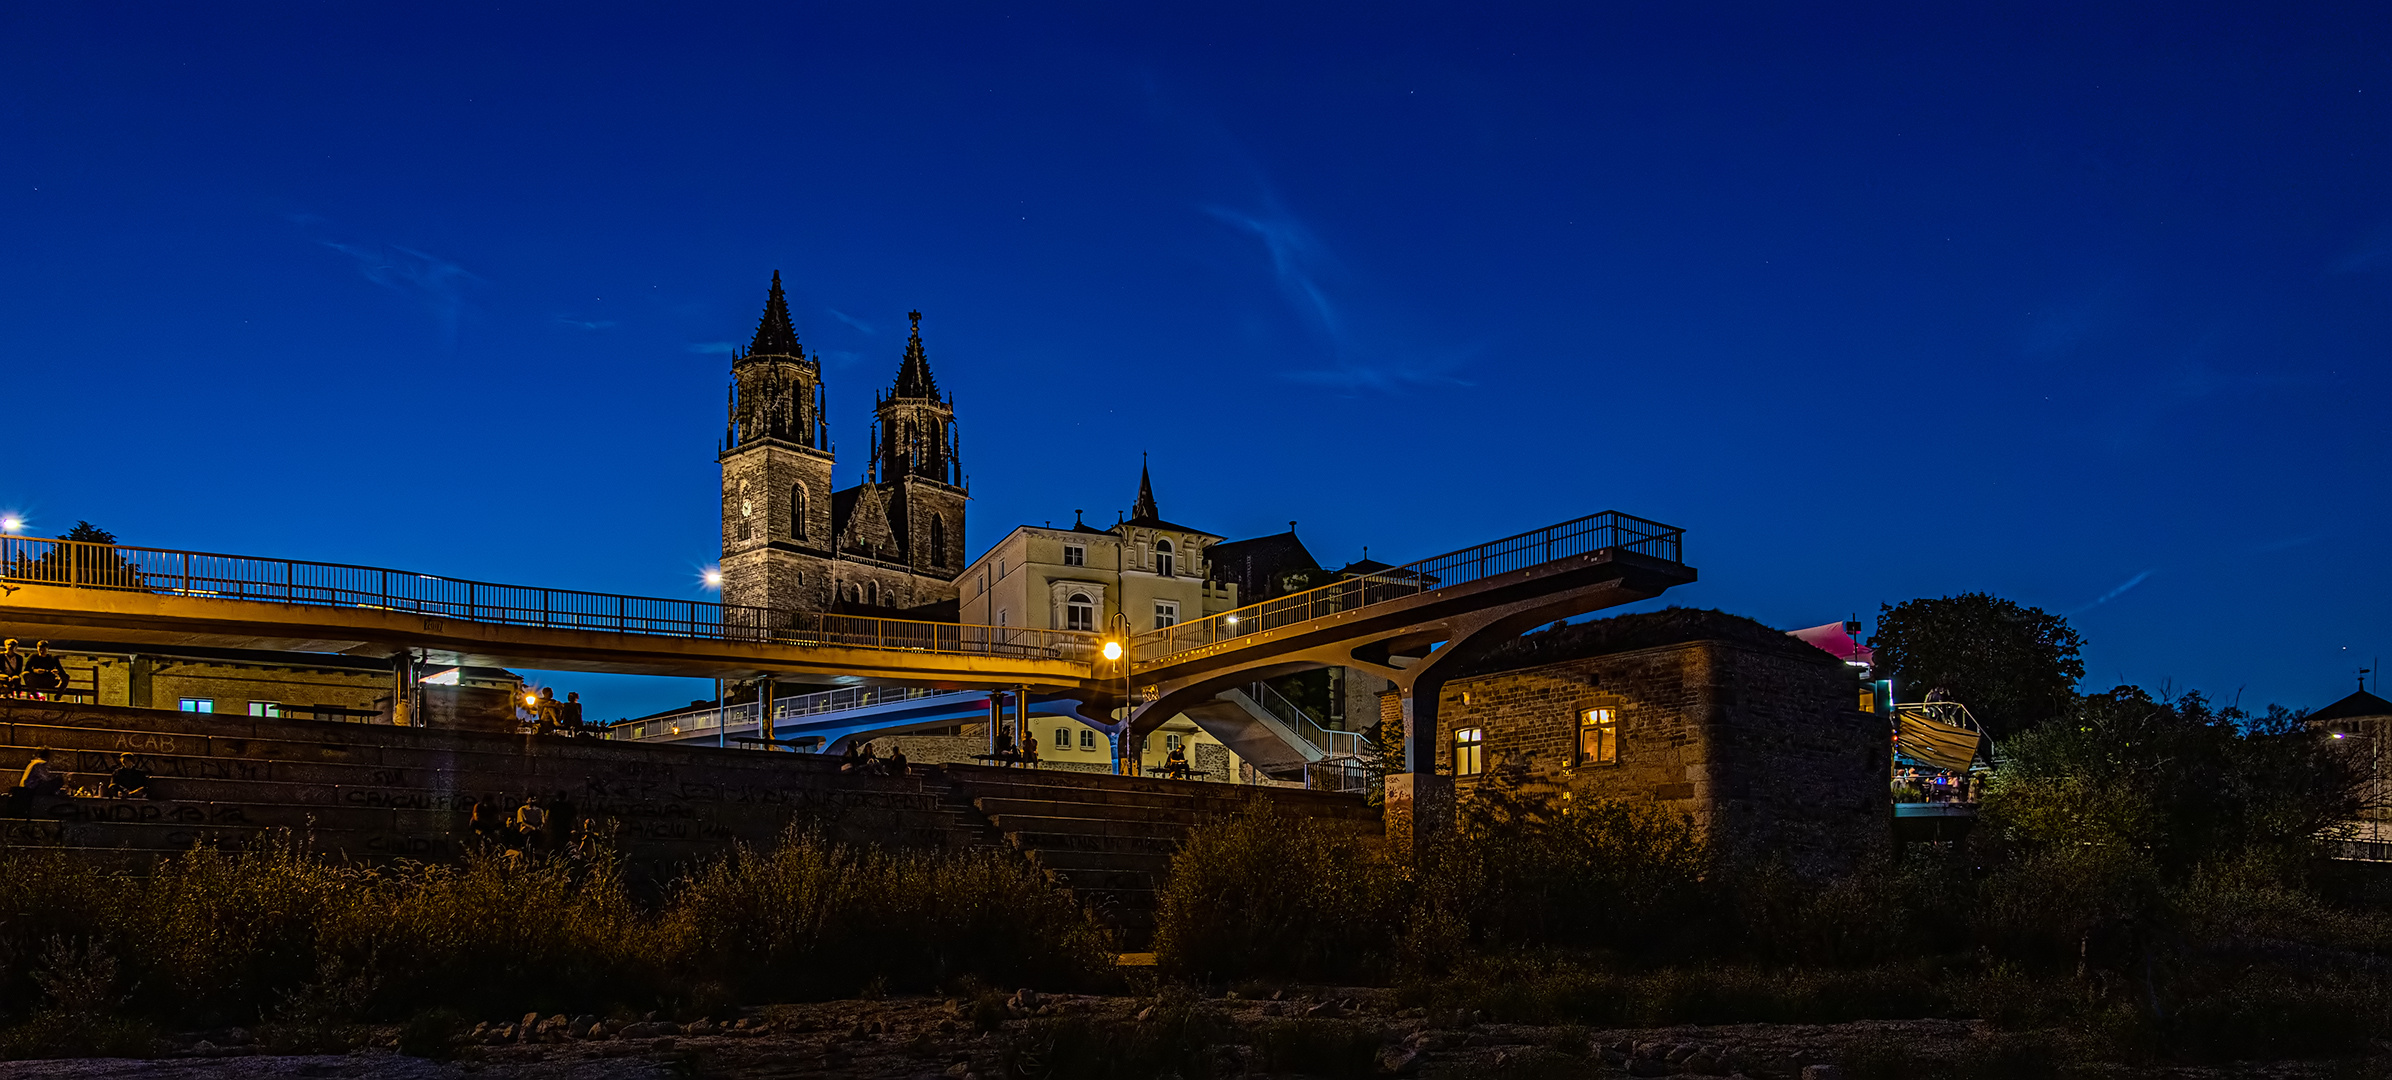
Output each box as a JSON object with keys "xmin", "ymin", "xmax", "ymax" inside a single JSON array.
[{"xmin": 1158, "ymin": 688, "xmax": 2392, "ymax": 1068}]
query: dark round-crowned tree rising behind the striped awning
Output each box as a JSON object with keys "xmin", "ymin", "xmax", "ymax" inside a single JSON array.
[{"xmin": 1868, "ymin": 593, "xmax": 2086, "ymax": 736}]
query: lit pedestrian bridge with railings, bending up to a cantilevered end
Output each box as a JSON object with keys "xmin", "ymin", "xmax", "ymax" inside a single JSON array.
[{"xmin": 0, "ymin": 511, "xmax": 1694, "ymax": 734}]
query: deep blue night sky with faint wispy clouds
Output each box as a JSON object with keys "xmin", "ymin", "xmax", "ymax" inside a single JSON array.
[{"xmin": 0, "ymin": 2, "xmax": 2392, "ymax": 714}]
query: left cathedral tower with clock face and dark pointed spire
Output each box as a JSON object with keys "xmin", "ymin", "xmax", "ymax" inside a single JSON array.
[{"xmin": 718, "ymin": 270, "xmax": 835, "ymax": 612}]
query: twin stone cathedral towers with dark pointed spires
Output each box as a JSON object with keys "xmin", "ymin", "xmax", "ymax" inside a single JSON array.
[{"xmin": 720, "ymin": 270, "xmax": 969, "ymax": 621}]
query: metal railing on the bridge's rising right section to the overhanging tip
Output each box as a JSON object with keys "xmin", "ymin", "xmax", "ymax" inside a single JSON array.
[{"xmin": 1131, "ymin": 511, "xmax": 1686, "ymax": 664}]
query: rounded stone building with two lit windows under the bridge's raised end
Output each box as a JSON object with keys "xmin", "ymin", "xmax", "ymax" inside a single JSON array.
[{"xmin": 1438, "ymin": 607, "xmax": 1890, "ymax": 870}]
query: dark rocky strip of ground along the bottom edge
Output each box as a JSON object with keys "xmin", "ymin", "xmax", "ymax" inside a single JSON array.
[{"xmin": 0, "ymin": 989, "xmax": 2392, "ymax": 1080}]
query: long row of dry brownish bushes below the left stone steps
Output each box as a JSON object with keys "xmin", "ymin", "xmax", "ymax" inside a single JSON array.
[{"xmin": 0, "ymin": 832, "xmax": 1110, "ymax": 1056}]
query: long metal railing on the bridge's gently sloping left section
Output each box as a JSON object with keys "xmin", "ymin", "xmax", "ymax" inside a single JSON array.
[{"xmin": 0, "ymin": 535, "xmax": 1096, "ymax": 662}]
